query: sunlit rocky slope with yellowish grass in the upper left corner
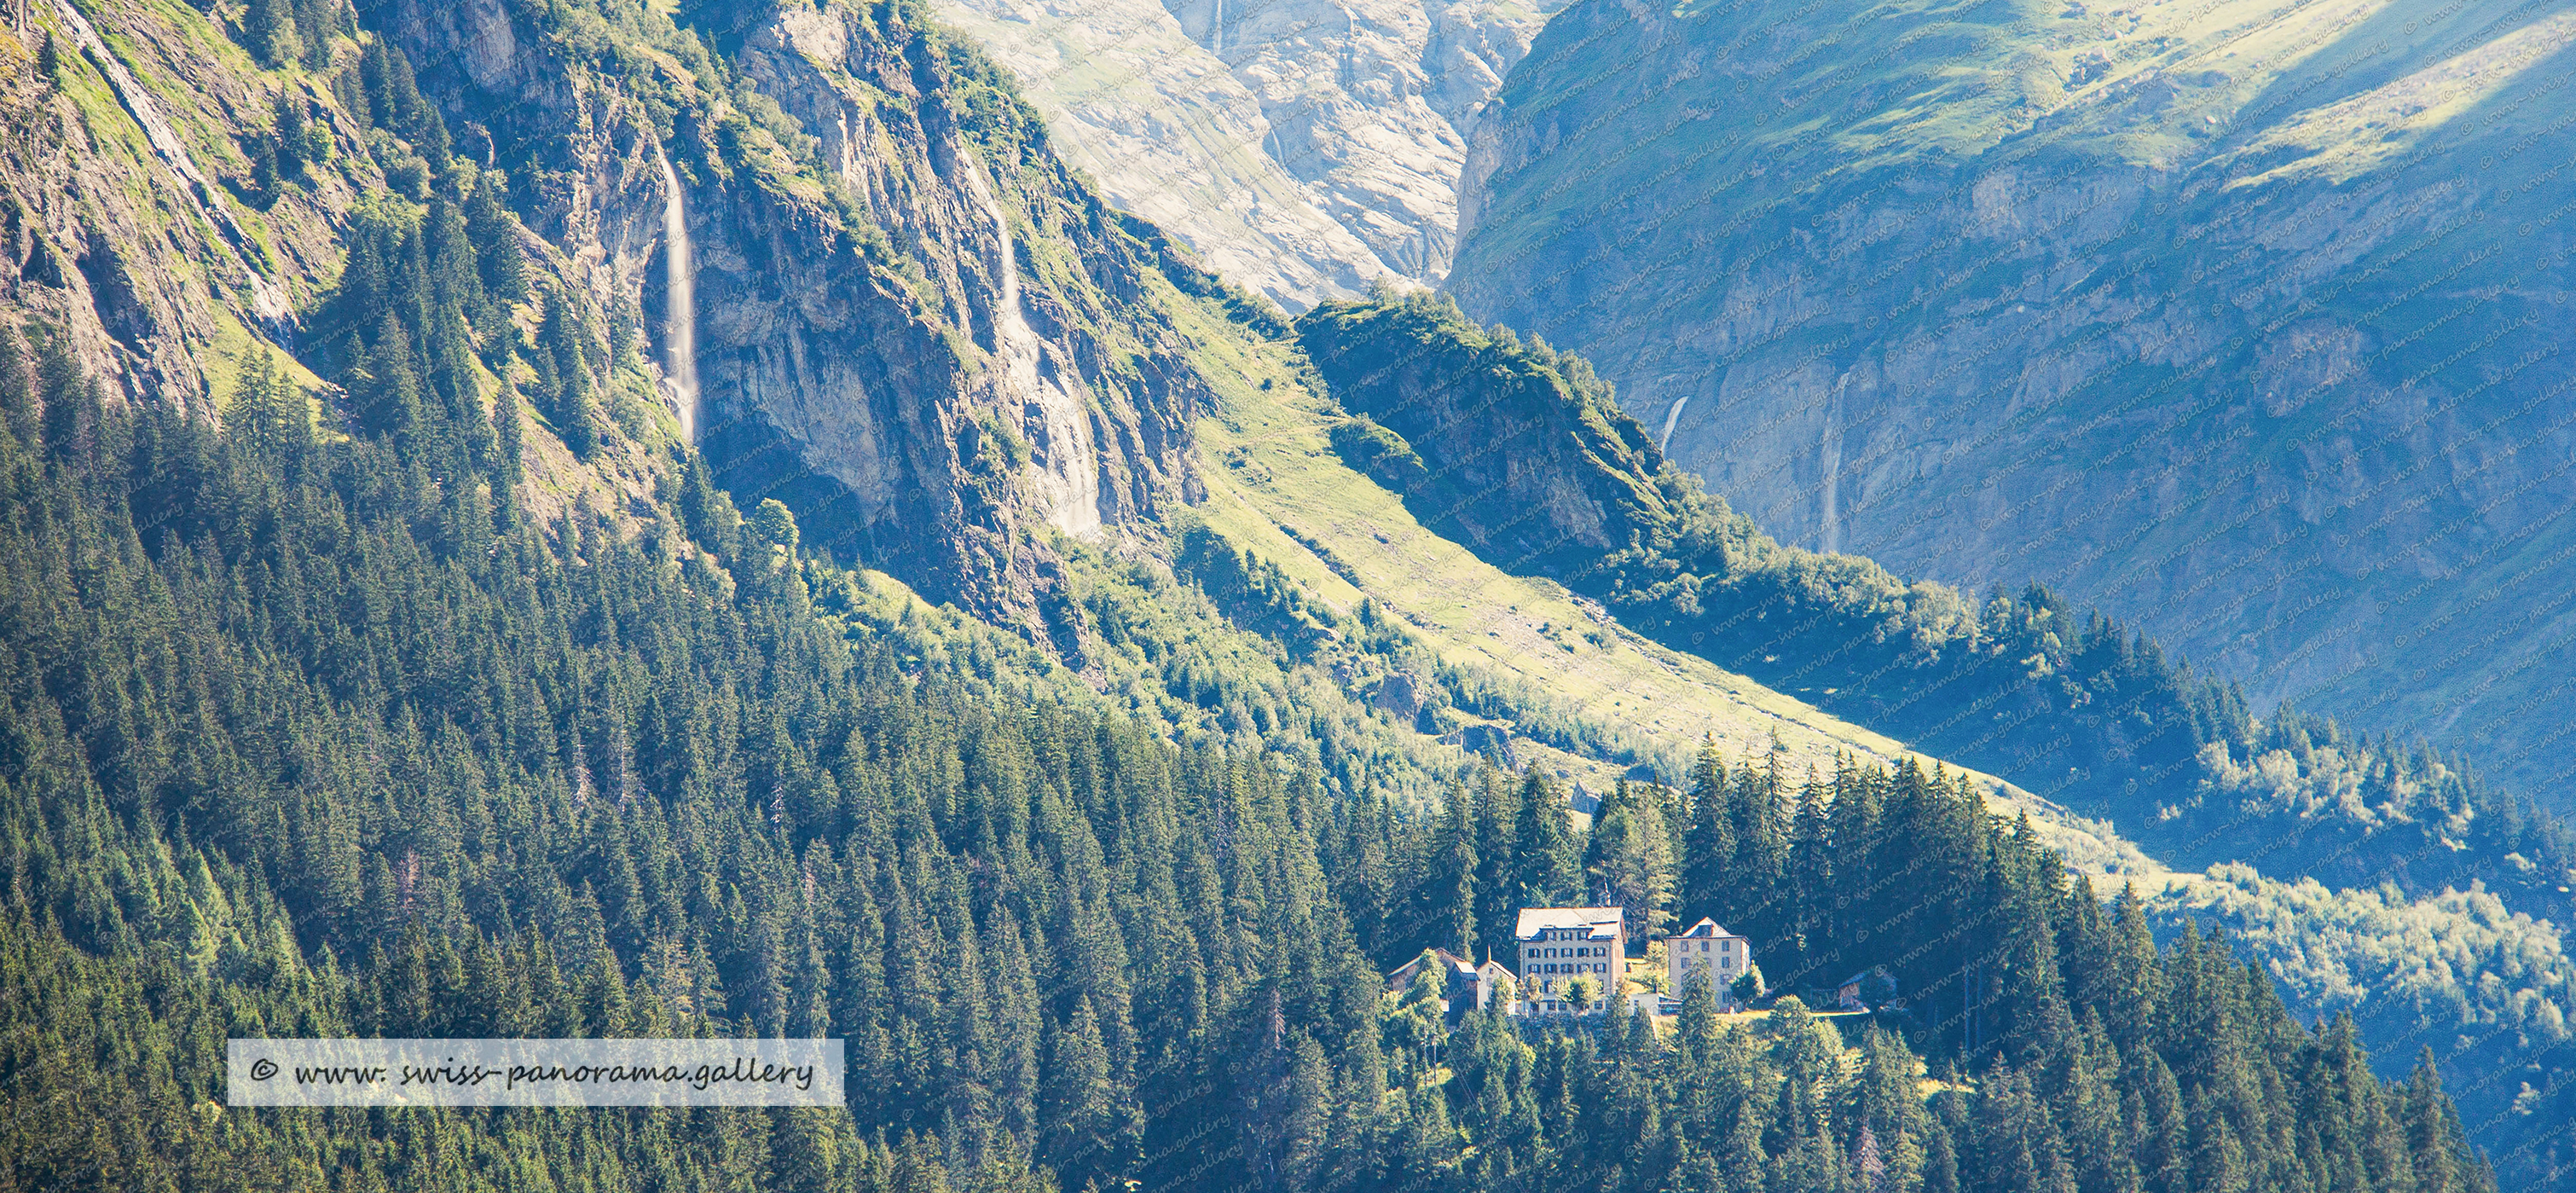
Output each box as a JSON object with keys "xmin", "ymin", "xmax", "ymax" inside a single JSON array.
[{"xmin": 0, "ymin": 0, "xmax": 381, "ymax": 412}]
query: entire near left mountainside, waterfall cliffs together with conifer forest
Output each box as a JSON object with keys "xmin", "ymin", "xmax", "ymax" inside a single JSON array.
[{"xmin": 0, "ymin": 0, "xmax": 2561, "ymax": 1193}]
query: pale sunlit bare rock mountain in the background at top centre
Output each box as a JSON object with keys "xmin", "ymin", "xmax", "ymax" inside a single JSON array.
[{"xmin": 938, "ymin": 0, "xmax": 1564, "ymax": 310}]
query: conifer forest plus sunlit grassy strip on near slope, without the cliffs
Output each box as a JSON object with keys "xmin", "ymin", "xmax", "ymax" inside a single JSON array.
[{"xmin": 0, "ymin": 0, "xmax": 2556, "ymax": 1193}]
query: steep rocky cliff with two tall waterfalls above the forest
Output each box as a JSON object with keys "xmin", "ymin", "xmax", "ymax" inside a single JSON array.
[{"xmin": 389, "ymin": 3, "xmax": 1203, "ymax": 631}]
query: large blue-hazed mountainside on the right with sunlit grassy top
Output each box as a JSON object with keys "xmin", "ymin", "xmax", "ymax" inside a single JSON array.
[{"xmin": 1450, "ymin": 0, "xmax": 2576, "ymax": 809}]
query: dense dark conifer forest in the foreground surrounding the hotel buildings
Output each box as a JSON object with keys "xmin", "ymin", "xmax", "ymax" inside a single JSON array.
[{"xmin": 0, "ymin": 361, "xmax": 2488, "ymax": 1190}]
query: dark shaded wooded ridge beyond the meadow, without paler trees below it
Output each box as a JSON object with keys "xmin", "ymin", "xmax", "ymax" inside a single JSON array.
[{"xmin": 1299, "ymin": 296, "xmax": 2576, "ymax": 920}]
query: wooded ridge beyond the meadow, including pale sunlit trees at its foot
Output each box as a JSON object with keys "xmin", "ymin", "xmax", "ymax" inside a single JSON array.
[{"xmin": 1299, "ymin": 296, "xmax": 2576, "ymax": 1178}]
